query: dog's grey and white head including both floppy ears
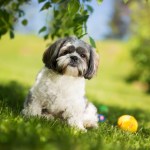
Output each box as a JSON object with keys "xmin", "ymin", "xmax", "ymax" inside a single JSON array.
[{"xmin": 43, "ymin": 37, "xmax": 99, "ymax": 79}]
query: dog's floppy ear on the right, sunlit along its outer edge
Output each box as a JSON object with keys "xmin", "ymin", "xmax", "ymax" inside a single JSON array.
[{"xmin": 84, "ymin": 48, "xmax": 99, "ymax": 79}]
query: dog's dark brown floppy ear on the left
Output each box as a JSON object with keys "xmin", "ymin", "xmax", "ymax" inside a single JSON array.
[{"xmin": 43, "ymin": 39, "xmax": 66, "ymax": 70}]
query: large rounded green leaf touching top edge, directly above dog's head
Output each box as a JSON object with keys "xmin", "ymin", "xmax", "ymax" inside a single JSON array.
[{"xmin": 68, "ymin": 0, "xmax": 80, "ymax": 14}]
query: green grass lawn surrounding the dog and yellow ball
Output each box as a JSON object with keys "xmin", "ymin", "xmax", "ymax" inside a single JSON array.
[{"xmin": 0, "ymin": 35, "xmax": 150, "ymax": 150}]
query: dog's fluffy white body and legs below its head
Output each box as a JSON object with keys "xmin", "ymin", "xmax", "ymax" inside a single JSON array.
[{"xmin": 22, "ymin": 67, "xmax": 97, "ymax": 130}]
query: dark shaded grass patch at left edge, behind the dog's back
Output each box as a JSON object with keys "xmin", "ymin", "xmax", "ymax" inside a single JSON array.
[{"xmin": 0, "ymin": 81, "xmax": 28, "ymax": 113}]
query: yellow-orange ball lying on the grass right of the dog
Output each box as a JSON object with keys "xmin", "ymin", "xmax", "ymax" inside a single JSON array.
[{"xmin": 118, "ymin": 115, "xmax": 138, "ymax": 132}]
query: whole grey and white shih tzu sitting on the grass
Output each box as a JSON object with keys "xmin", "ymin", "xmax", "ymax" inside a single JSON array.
[{"xmin": 22, "ymin": 37, "xmax": 99, "ymax": 130}]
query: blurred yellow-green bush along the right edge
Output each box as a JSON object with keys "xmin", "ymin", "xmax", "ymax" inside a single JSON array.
[{"xmin": 129, "ymin": 1, "xmax": 150, "ymax": 92}]
